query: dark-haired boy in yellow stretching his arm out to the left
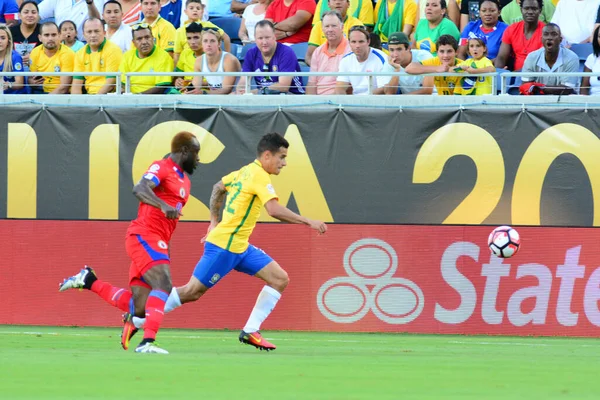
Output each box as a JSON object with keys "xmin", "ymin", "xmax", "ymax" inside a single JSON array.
[{"xmin": 406, "ymin": 35, "xmax": 461, "ymax": 96}]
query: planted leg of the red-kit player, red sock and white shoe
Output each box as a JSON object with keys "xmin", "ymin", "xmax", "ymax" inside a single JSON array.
[{"xmin": 135, "ymin": 263, "xmax": 173, "ymax": 354}]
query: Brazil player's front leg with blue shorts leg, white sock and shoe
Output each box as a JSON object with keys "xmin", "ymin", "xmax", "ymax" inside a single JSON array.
[{"xmin": 236, "ymin": 245, "xmax": 289, "ymax": 350}]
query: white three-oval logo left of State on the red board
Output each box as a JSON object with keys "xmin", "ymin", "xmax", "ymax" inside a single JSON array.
[{"xmin": 317, "ymin": 238, "xmax": 425, "ymax": 324}]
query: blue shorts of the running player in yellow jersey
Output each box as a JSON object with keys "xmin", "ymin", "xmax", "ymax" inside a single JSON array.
[{"xmin": 193, "ymin": 242, "xmax": 273, "ymax": 288}]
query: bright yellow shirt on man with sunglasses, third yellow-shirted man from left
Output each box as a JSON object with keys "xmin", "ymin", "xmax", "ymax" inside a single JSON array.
[{"xmin": 119, "ymin": 45, "xmax": 173, "ymax": 93}]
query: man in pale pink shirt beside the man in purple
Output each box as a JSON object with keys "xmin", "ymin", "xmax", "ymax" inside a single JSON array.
[{"xmin": 306, "ymin": 10, "xmax": 351, "ymax": 94}]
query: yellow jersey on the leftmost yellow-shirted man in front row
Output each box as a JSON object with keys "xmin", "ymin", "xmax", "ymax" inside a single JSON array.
[{"xmin": 29, "ymin": 44, "xmax": 75, "ymax": 93}]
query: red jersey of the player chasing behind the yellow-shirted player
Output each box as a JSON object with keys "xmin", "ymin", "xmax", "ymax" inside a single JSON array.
[{"xmin": 127, "ymin": 157, "xmax": 191, "ymax": 243}]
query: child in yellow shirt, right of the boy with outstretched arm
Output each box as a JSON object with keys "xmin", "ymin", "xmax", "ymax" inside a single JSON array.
[{"xmin": 454, "ymin": 37, "xmax": 496, "ymax": 96}]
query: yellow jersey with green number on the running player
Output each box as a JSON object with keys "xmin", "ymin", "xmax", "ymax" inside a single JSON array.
[{"xmin": 206, "ymin": 160, "xmax": 278, "ymax": 253}]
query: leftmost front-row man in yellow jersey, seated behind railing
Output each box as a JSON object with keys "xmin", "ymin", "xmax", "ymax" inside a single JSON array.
[{"xmin": 29, "ymin": 22, "xmax": 75, "ymax": 94}]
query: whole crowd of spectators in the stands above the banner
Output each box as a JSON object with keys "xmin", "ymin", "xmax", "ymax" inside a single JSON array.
[{"xmin": 0, "ymin": 0, "xmax": 600, "ymax": 95}]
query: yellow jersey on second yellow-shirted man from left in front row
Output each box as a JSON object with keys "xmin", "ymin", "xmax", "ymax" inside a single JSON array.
[{"xmin": 74, "ymin": 39, "xmax": 123, "ymax": 94}]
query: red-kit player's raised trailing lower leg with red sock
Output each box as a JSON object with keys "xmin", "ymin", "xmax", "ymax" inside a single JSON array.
[{"xmin": 58, "ymin": 265, "xmax": 132, "ymax": 312}]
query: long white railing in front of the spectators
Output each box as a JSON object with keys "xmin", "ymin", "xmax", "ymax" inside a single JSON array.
[{"xmin": 0, "ymin": 71, "xmax": 600, "ymax": 95}]
